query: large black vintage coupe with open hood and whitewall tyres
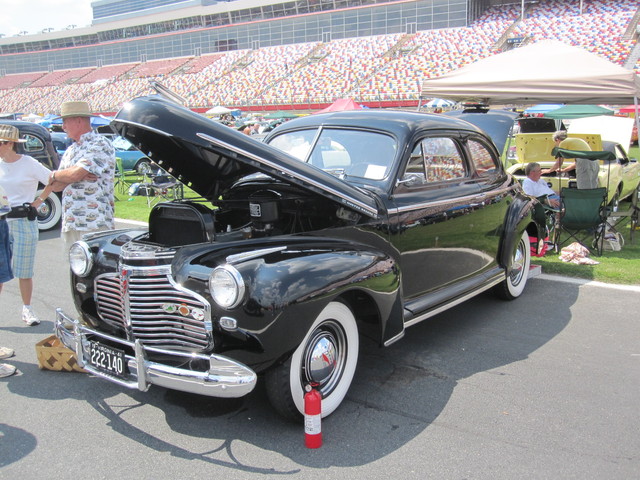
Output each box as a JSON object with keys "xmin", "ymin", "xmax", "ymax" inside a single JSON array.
[{"xmin": 56, "ymin": 91, "xmax": 542, "ymax": 418}]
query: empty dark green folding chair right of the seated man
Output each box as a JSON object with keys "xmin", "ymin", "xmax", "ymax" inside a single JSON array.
[{"xmin": 553, "ymin": 188, "xmax": 608, "ymax": 255}]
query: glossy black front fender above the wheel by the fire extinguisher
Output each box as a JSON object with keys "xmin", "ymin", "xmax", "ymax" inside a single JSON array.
[{"xmin": 201, "ymin": 244, "xmax": 400, "ymax": 370}]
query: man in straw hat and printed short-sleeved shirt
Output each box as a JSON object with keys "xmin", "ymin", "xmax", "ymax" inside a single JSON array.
[{"xmin": 50, "ymin": 101, "xmax": 116, "ymax": 253}]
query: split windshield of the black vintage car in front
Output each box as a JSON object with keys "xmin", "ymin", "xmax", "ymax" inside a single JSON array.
[{"xmin": 269, "ymin": 128, "xmax": 397, "ymax": 180}]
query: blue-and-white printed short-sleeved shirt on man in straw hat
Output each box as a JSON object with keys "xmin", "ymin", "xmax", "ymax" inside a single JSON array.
[{"xmin": 60, "ymin": 131, "xmax": 116, "ymax": 232}]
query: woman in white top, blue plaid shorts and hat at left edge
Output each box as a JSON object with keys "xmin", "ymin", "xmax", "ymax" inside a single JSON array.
[{"xmin": 0, "ymin": 125, "xmax": 52, "ymax": 326}]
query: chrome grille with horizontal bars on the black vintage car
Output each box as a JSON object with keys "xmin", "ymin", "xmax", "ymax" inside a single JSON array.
[{"xmin": 95, "ymin": 264, "xmax": 213, "ymax": 351}]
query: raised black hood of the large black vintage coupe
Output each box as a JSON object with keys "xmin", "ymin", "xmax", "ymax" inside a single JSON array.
[{"xmin": 111, "ymin": 95, "xmax": 378, "ymax": 218}]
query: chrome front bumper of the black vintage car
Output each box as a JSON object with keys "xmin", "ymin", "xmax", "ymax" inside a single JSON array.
[{"xmin": 55, "ymin": 308, "xmax": 257, "ymax": 398}]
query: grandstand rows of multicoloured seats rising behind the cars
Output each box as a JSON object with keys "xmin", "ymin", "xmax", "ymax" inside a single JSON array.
[{"xmin": 0, "ymin": 0, "xmax": 639, "ymax": 113}]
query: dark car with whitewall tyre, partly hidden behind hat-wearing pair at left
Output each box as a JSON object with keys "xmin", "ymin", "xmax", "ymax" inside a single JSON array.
[{"xmin": 0, "ymin": 119, "xmax": 62, "ymax": 231}]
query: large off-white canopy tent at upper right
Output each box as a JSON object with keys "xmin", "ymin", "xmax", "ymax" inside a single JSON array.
[{"xmin": 421, "ymin": 40, "xmax": 640, "ymax": 105}]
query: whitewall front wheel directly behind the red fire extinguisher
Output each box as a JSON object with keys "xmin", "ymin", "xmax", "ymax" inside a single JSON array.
[{"xmin": 265, "ymin": 302, "xmax": 359, "ymax": 420}]
